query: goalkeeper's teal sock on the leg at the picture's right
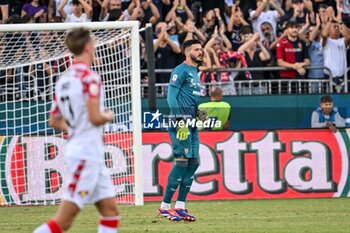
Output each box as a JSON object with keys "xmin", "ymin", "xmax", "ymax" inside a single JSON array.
[{"xmin": 177, "ymin": 159, "xmax": 199, "ymax": 202}]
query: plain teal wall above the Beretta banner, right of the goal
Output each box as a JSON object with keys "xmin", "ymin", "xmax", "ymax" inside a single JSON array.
[{"xmin": 142, "ymin": 94, "xmax": 350, "ymax": 130}]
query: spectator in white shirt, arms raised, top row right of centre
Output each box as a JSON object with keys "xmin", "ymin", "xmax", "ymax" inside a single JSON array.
[{"xmin": 250, "ymin": 0, "xmax": 284, "ymax": 38}]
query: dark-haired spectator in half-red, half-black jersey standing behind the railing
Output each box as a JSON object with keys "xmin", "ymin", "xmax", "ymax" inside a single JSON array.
[{"xmin": 276, "ymin": 21, "xmax": 310, "ymax": 93}]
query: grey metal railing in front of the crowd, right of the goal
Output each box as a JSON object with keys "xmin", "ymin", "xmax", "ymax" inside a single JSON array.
[{"xmin": 141, "ymin": 66, "xmax": 336, "ymax": 97}]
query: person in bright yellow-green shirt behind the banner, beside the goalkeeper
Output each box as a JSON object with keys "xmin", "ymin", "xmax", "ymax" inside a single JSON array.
[{"xmin": 198, "ymin": 86, "xmax": 231, "ymax": 130}]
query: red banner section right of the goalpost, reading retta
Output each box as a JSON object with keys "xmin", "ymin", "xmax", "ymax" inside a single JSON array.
[{"xmin": 143, "ymin": 130, "xmax": 350, "ymax": 201}]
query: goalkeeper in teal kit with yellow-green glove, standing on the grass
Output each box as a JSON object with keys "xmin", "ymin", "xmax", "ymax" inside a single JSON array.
[{"xmin": 158, "ymin": 40, "xmax": 206, "ymax": 221}]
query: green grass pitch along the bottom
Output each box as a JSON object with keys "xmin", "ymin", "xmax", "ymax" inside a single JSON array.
[{"xmin": 0, "ymin": 198, "xmax": 350, "ymax": 233}]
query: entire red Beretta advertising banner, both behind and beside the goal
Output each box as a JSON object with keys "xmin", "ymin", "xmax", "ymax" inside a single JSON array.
[{"xmin": 0, "ymin": 129, "xmax": 350, "ymax": 205}]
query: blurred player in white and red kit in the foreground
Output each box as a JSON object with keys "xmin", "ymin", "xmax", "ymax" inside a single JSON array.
[{"xmin": 34, "ymin": 28, "xmax": 119, "ymax": 233}]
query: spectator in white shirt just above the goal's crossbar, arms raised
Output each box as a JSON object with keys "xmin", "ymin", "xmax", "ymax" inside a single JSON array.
[{"xmin": 58, "ymin": 0, "xmax": 92, "ymax": 23}]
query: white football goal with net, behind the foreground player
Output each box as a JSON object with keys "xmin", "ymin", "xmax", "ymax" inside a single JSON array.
[{"xmin": 0, "ymin": 22, "xmax": 143, "ymax": 206}]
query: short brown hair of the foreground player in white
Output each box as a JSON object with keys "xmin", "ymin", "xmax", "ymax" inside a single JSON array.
[{"xmin": 65, "ymin": 27, "xmax": 91, "ymax": 56}]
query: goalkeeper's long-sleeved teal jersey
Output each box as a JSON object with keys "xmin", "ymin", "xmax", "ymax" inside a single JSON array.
[{"xmin": 167, "ymin": 62, "xmax": 201, "ymax": 118}]
